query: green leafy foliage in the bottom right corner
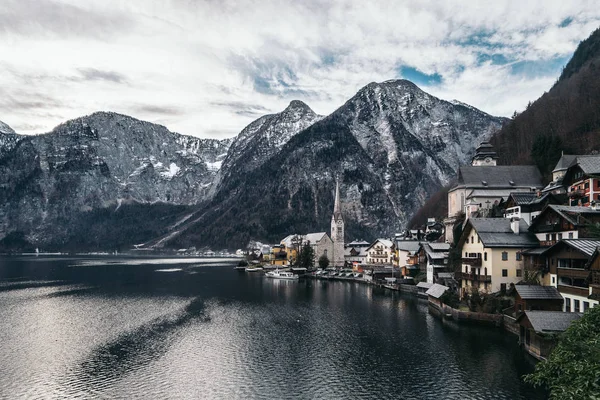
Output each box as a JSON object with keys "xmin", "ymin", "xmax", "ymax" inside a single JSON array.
[{"xmin": 524, "ymin": 307, "xmax": 600, "ymax": 400}]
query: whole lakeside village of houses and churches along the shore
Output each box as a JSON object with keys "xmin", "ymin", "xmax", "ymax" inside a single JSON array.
[{"xmin": 244, "ymin": 142, "xmax": 600, "ymax": 359}]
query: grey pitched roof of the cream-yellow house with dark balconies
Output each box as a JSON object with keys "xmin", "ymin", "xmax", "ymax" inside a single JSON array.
[{"xmin": 463, "ymin": 218, "xmax": 539, "ymax": 247}]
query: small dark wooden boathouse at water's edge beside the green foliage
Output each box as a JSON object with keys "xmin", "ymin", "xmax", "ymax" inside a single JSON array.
[{"xmin": 517, "ymin": 310, "xmax": 582, "ymax": 360}]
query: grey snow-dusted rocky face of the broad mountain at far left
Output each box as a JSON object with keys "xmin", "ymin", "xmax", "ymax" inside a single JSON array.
[{"xmin": 0, "ymin": 112, "xmax": 231, "ymax": 246}]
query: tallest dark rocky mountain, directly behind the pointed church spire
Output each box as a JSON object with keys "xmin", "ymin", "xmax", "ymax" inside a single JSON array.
[{"xmin": 160, "ymin": 80, "xmax": 504, "ymax": 247}]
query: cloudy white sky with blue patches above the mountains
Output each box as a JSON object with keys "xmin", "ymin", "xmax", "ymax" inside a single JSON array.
[{"xmin": 0, "ymin": 0, "xmax": 600, "ymax": 138}]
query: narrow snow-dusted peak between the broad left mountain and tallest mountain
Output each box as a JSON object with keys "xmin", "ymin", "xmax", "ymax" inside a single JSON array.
[{"xmin": 211, "ymin": 100, "xmax": 323, "ymax": 194}]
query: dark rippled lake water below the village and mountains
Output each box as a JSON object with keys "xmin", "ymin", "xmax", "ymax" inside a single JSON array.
[{"xmin": 0, "ymin": 257, "xmax": 546, "ymax": 399}]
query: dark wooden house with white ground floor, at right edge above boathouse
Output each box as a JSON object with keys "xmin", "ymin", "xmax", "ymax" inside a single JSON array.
[{"xmin": 543, "ymin": 239, "xmax": 600, "ymax": 312}]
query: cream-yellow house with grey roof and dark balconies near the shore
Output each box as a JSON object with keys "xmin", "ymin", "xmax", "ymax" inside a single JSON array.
[{"xmin": 456, "ymin": 218, "xmax": 539, "ymax": 295}]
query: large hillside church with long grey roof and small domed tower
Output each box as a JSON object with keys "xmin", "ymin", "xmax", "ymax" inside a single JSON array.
[{"xmin": 444, "ymin": 142, "xmax": 543, "ymax": 243}]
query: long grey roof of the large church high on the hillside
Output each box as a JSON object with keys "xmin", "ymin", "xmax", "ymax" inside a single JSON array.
[{"xmin": 458, "ymin": 165, "xmax": 543, "ymax": 188}]
